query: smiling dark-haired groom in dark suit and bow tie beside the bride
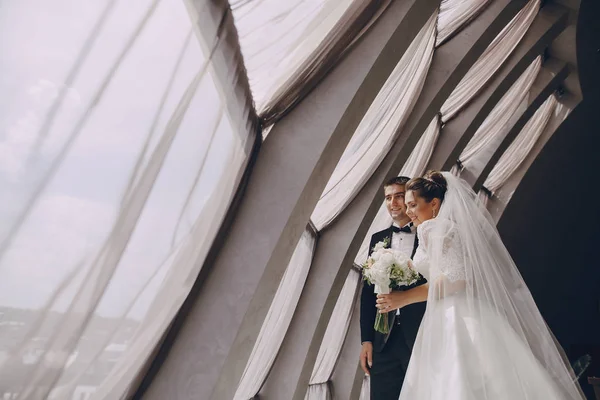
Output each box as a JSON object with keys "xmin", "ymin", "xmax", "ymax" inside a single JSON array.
[{"xmin": 360, "ymin": 176, "xmax": 426, "ymax": 400}]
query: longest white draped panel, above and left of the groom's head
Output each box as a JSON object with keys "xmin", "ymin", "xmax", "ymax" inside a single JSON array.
[{"xmin": 311, "ymin": 12, "xmax": 437, "ymax": 230}]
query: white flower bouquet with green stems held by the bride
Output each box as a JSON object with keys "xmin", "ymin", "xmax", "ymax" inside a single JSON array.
[{"xmin": 362, "ymin": 241, "xmax": 419, "ymax": 334}]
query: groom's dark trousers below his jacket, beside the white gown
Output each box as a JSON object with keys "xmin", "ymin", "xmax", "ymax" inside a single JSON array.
[{"xmin": 370, "ymin": 325, "xmax": 411, "ymax": 400}]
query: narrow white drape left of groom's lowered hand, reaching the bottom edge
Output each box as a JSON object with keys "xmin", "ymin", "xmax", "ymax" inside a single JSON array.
[{"xmin": 305, "ymin": 268, "xmax": 361, "ymax": 400}]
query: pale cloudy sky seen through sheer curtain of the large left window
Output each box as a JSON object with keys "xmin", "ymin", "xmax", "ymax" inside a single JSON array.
[{"xmin": 0, "ymin": 0, "xmax": 241, "ymax": 318}]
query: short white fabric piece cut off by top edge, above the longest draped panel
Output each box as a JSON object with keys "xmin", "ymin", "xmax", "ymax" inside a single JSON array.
[{"xmin": 435, "ymin": 0, "xmax": 490, "ymax": 47}]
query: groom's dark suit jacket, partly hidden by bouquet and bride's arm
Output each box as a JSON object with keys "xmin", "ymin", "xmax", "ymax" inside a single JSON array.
[{"xmin": 360, "ymin": 226, "xmax": 427, "ymax": 352}]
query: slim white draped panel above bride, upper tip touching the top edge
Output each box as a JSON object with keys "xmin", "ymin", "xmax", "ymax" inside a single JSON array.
[{"xmin": 441, "ymin": 0, "xmax": 540, "ymax": 123}]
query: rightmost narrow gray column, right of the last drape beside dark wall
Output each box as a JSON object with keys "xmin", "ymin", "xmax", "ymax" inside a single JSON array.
[{"xmin": 487, "ymin": 89, "xmax": 581, "ymax": 222}]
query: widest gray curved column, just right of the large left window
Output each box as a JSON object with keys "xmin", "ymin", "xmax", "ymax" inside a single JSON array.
[{"xmin": 145, "ymin": 0, "xmax": 437, "ymax": 400}]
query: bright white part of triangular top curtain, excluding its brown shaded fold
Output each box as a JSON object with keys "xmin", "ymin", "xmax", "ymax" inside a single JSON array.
[{"xmin": 231, "ymin": 0, "xmax": 380, "ymax": 114}]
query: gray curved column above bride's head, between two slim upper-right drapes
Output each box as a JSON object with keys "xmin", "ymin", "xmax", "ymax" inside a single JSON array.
[{"xmin": 427, "ymin": 5, "xmax": 568, "ymax": 170}]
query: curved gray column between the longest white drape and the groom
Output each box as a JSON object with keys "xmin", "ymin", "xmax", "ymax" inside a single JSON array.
[{"xmin": 260, "ymin": 0, "xmax": 525, "ymax": 400}]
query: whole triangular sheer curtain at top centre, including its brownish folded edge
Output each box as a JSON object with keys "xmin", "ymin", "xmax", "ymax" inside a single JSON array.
[{"xmin": 230, "ymin": 0, "xmax": 391, "ymax": 124}]
